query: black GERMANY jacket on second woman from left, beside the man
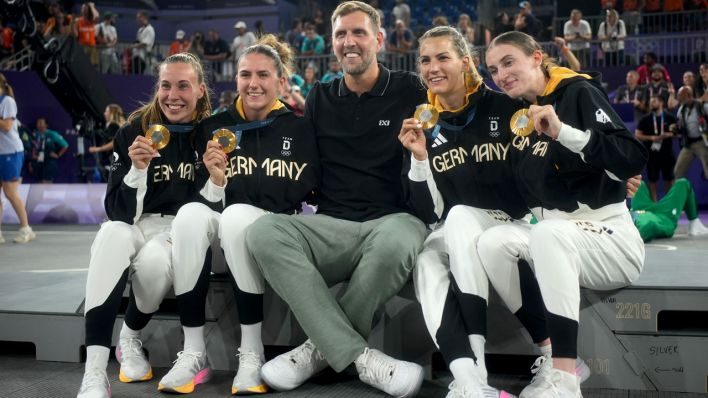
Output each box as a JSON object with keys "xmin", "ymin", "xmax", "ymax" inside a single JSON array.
[{"xmin": 195, "ymin": 103, "xmax": 319, "ymax": 213}]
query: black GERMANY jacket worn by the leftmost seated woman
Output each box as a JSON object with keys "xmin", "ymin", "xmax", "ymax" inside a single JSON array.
[{"xmin": 104, "ymin": 118, "xmax": 197, "ymax": 224}]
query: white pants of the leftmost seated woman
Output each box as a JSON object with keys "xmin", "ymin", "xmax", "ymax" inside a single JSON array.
[{"xmin": 84, "ymin": 214, "xmax": 174, "ymax": 314}]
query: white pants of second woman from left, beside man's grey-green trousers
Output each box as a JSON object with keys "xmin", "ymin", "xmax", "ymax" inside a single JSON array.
[{"xmin": 172, "ymin": 202, "xmax": 268, "ymax": 295}]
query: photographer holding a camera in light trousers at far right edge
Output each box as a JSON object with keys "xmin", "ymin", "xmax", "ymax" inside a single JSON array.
[{"xmin": 674, "ymin": 86, "xmax": 708, "ymax": 178}]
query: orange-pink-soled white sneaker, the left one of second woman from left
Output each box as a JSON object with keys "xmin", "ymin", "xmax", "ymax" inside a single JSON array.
[{"xmin": 157, "ymin": 351, "xmax": 211, "ymax": 394}]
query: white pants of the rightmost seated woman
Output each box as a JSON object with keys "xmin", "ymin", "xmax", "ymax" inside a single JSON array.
[{"xmin": 477, "ymin": 212, "xmax": 644, "ymax": 322}]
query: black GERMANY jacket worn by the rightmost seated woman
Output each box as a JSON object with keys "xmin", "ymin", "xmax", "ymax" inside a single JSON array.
[{"xmin": 512, "ymin": 68, "xmax": 648, "ymax": 220}]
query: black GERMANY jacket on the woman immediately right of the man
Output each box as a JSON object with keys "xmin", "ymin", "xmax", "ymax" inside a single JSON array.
[{"xmin": 408, "ymin": 84, "xmax": 529, "ymax": 223}]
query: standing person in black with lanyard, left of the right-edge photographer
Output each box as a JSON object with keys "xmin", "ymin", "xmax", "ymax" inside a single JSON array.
[{"xmin": 635, "ymin": 93, "xmax": 678, "ymax": 202}]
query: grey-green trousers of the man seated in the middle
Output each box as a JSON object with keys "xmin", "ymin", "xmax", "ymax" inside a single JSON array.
[{"xmin": 246, "ymin": 213, "xmax": 426, "ymax": 372}]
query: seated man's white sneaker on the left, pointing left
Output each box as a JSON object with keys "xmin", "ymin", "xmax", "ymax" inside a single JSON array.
[{"xmin": 261, "ymin": 340, "xmax": 327, "ymax": 391}]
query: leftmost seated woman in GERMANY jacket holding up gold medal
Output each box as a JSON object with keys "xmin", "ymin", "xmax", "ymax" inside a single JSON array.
[{"xmin": 77, "ymin": 53, "xmax": 211, "ymax": 398}]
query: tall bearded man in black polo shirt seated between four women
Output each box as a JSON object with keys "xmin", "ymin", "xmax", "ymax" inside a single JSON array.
[{"xmin": 246, "ymin": 1, "xmax": 425, "ymax": 397}]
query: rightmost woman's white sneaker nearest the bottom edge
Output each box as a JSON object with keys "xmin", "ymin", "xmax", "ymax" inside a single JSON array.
[{"xmin": 519, "ymin": 356, "xmax": 590, "ymax": 398}]
